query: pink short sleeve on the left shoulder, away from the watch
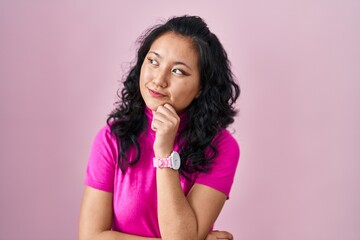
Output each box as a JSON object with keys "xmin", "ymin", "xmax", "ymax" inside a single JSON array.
[{"xmin": 85, "ymin": 126, "xmax": 117, "ymax": 192}]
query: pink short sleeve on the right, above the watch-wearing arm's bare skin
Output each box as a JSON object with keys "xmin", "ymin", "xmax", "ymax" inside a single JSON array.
[{"xmin": 195, "ymin": 129, "xmax": 240, "ymax": 198}]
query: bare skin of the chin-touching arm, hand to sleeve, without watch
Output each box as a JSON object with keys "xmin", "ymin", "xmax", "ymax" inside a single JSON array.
[{"xmin": 152, "ymin": 104, "xmax": 226, "ymax": 240}]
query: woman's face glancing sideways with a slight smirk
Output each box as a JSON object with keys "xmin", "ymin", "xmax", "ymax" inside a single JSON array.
[{"xmin": 140, "ymin": 32, "xmax": 200, "ymax": 113}]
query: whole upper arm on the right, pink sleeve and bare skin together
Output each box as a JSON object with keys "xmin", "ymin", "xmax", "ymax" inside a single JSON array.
[{"xmin": 187, "ymin": 130, "xmax": 240, "ymax": 239}]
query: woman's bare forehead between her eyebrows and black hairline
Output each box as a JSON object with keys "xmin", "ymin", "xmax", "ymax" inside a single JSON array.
[{"xmin": 150, "ymin": 32, "xmax": 198, "ymax": 64}]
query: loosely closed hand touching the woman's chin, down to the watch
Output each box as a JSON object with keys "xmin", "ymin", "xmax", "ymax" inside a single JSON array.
[{"xmin": 151, "ymin": 103, "xmax": 180, "ymax": 157}]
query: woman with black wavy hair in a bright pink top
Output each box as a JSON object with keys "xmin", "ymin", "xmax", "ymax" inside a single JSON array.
[{"xmin": 79, "ymin": 16, "xmax": 240, "ymax": 240}]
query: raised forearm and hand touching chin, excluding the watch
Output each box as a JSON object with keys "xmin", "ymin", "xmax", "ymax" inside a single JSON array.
[{"xmin": 152, "ymin": 106, "xmax": 198, "ymax": 240}]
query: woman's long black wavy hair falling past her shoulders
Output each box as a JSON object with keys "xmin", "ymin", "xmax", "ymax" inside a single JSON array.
[{"xmin": 107, "ymin": 15, "xmax": 240, "ymax": 175}]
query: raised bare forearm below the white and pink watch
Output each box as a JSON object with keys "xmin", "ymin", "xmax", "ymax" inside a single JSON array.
[{"xmin": 156, "ymin": 168, "xmax": 198, "ymax": 240}]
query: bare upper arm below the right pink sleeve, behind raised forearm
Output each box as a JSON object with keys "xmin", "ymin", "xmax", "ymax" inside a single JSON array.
[{"xmin": 187, "ymin": 184, "xmax": 226, "ymax": 239}]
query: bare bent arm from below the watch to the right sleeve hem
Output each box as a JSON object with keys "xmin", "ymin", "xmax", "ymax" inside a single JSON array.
[{"xmin": 157, "ymin": 172, "xmax": 226, "ymax": 240}]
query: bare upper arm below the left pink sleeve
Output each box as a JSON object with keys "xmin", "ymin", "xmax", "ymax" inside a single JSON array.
[{"xmin": 79, "ymin": 186, "xmax": 113, "ymax": 240}]
